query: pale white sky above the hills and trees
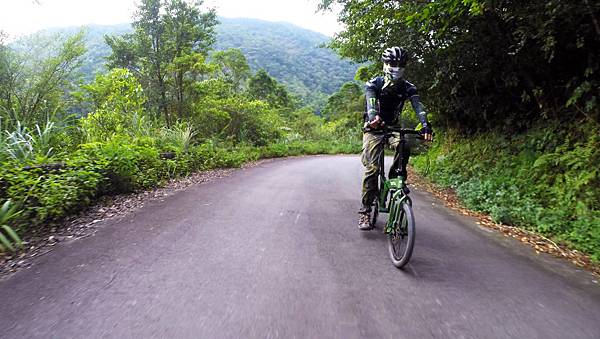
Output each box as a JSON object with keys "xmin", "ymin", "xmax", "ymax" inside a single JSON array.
[{"xmin": 0, "ymin": 0, "xmax": 341, "ymax": 39}]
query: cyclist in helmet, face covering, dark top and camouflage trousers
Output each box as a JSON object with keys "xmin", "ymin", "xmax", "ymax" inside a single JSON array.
[{"xmin": 358, "ymin": 47, "xmax": 432, "ymax": 230}]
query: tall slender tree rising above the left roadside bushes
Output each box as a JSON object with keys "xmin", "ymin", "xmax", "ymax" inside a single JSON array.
[{"xmin": 106, "ymin": 0, "xmax": 217, "ymax": 125}]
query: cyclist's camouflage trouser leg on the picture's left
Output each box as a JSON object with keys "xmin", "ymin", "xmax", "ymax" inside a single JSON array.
[{"xmin": 361, "ymin": 133, "xmax": 383, "ymax": 211}]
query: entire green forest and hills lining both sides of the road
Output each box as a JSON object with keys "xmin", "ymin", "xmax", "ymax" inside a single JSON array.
[{"xmin": 0, "ymin": 0, "xmax": 600, "ymax": 263}]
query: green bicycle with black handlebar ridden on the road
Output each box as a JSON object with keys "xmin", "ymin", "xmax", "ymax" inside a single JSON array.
[{"xmin": 371, "ymin": 127, "xmax": 422, "ymax": 268}]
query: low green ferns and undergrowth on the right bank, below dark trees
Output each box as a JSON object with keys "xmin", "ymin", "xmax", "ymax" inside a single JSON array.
[{"xmin": 414, "ymin": 125, "xmax": 600, "ymax": 260}]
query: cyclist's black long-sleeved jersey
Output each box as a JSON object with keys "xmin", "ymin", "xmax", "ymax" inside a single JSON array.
[{"xmin": 365, "ymin": 76, "xmax": 429, "ymax": 127}]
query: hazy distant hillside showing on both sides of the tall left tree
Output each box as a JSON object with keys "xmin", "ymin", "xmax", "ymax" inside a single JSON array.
[{"xmin": 13, "ymin": 18, "xmax": 357, "ymax": 102}]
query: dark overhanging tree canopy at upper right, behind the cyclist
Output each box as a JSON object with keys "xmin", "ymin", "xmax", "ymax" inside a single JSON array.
[{"xmin": 321, "ymin": 0, "xmax": 600, "ymax": 131}]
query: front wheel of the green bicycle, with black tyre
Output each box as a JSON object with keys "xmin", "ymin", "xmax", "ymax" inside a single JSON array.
[{"xmin": 388, "ymin": 200, "xmax": 415, "ymax": 268}]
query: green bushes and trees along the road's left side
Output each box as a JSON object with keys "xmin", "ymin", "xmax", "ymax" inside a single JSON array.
[{"xmin": 0, "ymin": 0, "xmax": 360, "ymax": 251}]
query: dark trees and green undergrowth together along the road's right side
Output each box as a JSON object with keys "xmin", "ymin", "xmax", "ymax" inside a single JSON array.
[{"xmin": 321, "ymin": 0, "xmax": 600, "ymax": 263}]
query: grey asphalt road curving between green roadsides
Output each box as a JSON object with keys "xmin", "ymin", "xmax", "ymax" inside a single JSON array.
[{"xmin": 0, "ymin": 156, "xmax": 600, "ymax": 339}]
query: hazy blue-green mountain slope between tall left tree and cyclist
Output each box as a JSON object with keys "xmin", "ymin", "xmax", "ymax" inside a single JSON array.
[{"xmin": 215, "ymin": 18, "xmax": 357, "ymax": 106}]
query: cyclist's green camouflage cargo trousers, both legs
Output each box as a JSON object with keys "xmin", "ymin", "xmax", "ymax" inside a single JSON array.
[{"xmin": 360, "ymin": 133, "xmax": 409, "ymax": 212}]
